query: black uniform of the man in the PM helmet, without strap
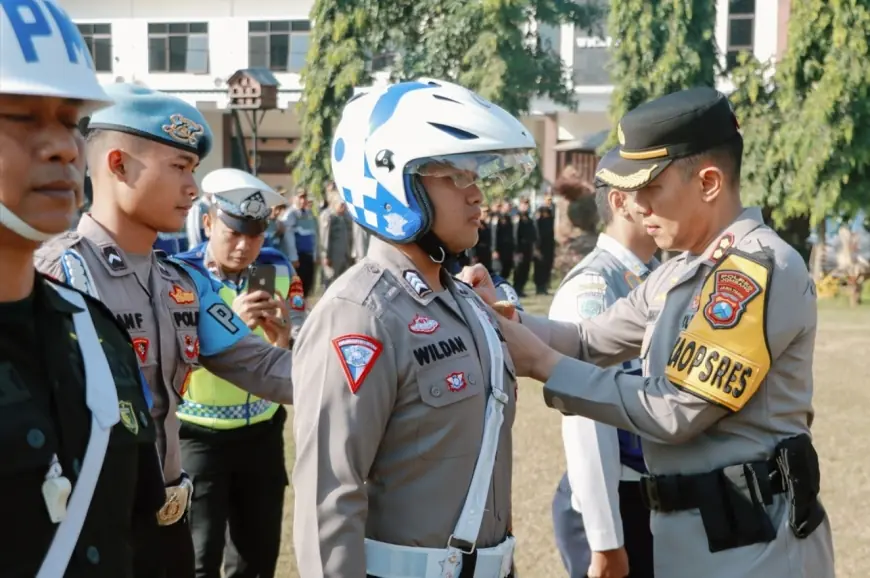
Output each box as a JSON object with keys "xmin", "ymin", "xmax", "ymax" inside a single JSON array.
[{"xmin": 0, "ymin": 275, "xmax": 164, "ymax": 578}]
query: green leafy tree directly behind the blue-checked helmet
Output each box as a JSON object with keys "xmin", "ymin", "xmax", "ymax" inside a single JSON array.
[{"xmin": 290, "ymin": 0, "xmax": 600, "ymax": 196}]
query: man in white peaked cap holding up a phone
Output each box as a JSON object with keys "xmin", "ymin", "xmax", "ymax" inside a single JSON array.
[{"xmin": 172, "ymin": 168, "xmax": 305, "ymax": 578}]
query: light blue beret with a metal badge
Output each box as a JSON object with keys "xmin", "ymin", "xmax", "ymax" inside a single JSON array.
[{"xmin": 88, "ymin": 83, "xmax": 214, "ymax": 159}]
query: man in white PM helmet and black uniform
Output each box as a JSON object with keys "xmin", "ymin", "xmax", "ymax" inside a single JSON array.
[{"xmin": 0, "ymin": 1, "xmax": 163, "ymax": 578}]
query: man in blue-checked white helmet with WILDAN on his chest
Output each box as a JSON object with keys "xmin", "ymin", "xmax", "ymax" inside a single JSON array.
[{"xmin": 293, "ymin": 80, "xmax": 535, "ymax": 578}]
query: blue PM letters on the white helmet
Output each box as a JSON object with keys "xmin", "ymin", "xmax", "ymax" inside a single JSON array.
[{"xmin": 0, "ymin": 0, "xmax": 94, "ymax": 70}]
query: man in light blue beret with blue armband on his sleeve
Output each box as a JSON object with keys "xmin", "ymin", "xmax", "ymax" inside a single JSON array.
[{"xmin": 36, "ymin": 84, "xmax": 292, "ymax": 577}]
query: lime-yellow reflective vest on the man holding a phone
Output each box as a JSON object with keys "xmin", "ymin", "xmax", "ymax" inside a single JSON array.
[{"xmin": 177, "ymin": 265, "xmax": 290, "ymax": 430}]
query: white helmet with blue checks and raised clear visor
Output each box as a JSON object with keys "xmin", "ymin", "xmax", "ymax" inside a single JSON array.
[{"xmin": 332, "ymin": 78, "xmax": 536, "ymax": 263}]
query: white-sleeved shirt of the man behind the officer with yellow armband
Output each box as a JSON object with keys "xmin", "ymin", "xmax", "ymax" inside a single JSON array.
[{"xmin": 550, "ymin": 233, "xmax": 658, "ymax": 552}]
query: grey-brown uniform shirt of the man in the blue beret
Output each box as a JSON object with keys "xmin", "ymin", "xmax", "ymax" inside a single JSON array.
[{"xmin": 35, "ymin": 215, "xmax": 293, "ymax": 483}]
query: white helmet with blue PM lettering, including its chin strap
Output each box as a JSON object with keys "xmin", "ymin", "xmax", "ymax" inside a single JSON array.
[{"xmin": 0, "ymin": 0, "xmax": 112, "ymax": 241}]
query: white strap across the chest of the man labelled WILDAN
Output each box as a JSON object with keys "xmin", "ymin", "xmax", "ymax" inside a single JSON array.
[{"xmin": 444, "ymin": 297, "xmax": 508, "ymax": 576}]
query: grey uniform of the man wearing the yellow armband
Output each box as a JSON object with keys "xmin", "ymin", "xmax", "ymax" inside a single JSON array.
[{"xmin": 520, "ymin": 208, "xmax": 834, "ymax": 578}]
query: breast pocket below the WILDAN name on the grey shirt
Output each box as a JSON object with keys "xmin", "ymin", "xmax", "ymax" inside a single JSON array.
[{"xmin": 417, "ymin": 353, "xmax": 486, "ymax": 461}]
